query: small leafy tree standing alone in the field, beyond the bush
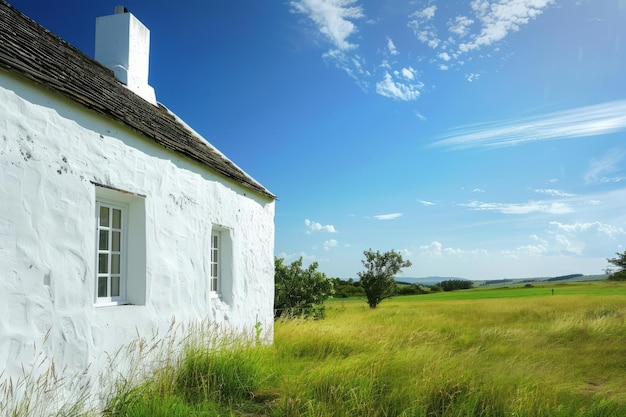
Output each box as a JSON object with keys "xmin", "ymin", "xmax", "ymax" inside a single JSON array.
[{"xmin": 358, "ymin": 249, "xmax": 411, "ymax": 308}]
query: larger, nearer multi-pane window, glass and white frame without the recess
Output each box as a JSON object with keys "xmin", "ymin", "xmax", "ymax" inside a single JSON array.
[{"xmin": 96, "ymin": 201, "xmax": 128, "ymax": 302}]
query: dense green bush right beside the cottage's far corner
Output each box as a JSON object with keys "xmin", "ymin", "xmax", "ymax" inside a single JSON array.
[{"xmin": 274, "ymin": 258, "xmax": 333, "ymax": 319}]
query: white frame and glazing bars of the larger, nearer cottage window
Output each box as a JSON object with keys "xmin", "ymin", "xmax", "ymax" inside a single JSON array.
[{"xmin": 96, "ymin": 200, "xmax": 128, "ymax": 305}]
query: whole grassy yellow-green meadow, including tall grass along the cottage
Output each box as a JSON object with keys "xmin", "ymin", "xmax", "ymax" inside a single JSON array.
[{"xmin": 2, "ymin": 281, "xmax": 626, "ymax": 417}]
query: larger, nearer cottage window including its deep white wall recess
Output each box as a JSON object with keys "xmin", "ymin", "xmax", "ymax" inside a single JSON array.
[{"xmin": 94, "ymin": 184, "xmax": 147, "ymax": 306}]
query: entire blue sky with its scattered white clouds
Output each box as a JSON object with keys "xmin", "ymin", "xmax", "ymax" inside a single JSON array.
[{"xmin": 10, "ymin": 0, "xmax": 626, "ymax": 279}]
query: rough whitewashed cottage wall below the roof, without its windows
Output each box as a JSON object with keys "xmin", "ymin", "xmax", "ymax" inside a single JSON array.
[{"xmin": 0, "ymin": 70, "xmax": 274, "ymax": 384}]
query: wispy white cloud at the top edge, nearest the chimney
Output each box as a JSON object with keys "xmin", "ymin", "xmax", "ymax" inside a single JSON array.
[{"xmin": 290, "ymin": 0, "xmax": 365, "ymax": 51}]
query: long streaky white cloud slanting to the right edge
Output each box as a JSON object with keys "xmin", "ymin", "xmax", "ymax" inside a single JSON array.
[{"xmin": 432, "ymin": 100, "xmax": 626, "ymax": 150}]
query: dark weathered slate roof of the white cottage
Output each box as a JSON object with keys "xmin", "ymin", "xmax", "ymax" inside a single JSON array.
[{"xmin": 0, "ymin": 0, "xmax": 275, "ymax": 199}]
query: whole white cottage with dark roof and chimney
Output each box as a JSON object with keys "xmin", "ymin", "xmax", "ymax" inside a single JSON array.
[{"xmin": 0, "ymin": 0, "xmax": 275, "ymax": 384}]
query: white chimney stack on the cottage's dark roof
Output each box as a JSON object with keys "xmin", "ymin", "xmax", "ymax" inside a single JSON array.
[{"xmin": 96, "ymin": 6, "xmax": 157, "ymax": 105}]
